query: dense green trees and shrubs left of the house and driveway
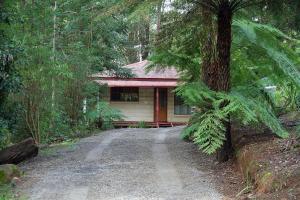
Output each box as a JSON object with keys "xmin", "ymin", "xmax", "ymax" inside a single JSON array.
[{"xmin": 0, "ymin": 0, "xmax": 131, "ymax": 147}]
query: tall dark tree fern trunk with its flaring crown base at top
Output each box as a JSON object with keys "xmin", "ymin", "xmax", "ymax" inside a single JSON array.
[{"xmin": 197, "ymin": 0, "xmax": 253, "ymax": 162}]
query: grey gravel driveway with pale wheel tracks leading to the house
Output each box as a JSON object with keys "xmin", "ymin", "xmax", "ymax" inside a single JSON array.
[{"xmin": 17, "ymin": 127, "xmax": 222, "ymax": 200}]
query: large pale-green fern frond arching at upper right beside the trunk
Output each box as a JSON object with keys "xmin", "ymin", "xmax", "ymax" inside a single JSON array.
[{"xmin": 233, "ymin": 20, "xmax": 300, "ymax": 87}]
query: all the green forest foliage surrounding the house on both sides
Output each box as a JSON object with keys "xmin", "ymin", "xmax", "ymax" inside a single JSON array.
[{"xmin": 0, "ymin": 0, "xmax": 300, "ymax": 156}]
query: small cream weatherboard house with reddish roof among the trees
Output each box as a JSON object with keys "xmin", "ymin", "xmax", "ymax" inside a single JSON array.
[{"xmin": 93, "ymin": 60, "xmax": 191, "ymax": 127}]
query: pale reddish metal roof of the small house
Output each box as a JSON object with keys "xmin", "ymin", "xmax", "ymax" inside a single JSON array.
[{"xmin": 92, "ymin": 60, "xmax": 179, "ymax": 87}]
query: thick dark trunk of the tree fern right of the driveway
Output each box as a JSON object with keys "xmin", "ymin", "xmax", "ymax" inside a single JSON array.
[{"xmin": 217, "ymin": 1, "xmax": 233, "ymax": 162}]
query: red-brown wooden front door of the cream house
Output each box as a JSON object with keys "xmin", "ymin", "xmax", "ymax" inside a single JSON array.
[{"xmin": 154, "ymin": 88, "xmax": 168, "ymax": 122}]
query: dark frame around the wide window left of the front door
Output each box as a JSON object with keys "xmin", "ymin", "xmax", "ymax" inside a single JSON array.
[{"xmin": 109, "ymin": 87, "xmax": 140, "ymax": 103}]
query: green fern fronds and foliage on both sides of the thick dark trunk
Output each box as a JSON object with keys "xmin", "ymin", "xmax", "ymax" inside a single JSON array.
[{"xmin": 145, "ymin": 3, "xmax": 300, "ymax": 153}]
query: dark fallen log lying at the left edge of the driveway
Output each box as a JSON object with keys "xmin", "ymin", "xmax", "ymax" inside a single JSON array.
[{"xmin": 0, "ymin": 138, "xmax": 38, "ymax": 165}]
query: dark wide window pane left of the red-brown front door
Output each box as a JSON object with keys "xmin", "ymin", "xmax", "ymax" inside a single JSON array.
[{"xmin": 110, "ymin": 87, "xmax": 139, "ymax": 102}]
